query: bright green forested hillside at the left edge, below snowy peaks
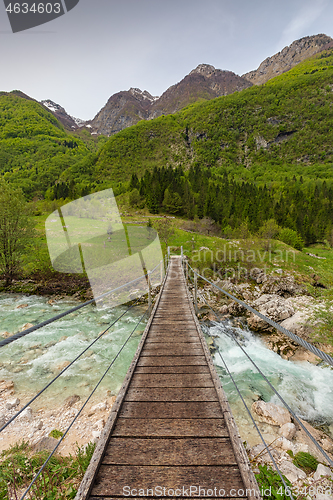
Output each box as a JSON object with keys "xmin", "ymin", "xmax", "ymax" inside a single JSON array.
[{"xmin": 0, "ymin": 93, "xmax": 93, "ymax": 199}]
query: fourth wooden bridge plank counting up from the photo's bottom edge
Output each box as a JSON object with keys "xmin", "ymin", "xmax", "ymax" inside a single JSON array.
[{"xmin": 119, "ymin": 401, "xmax": 223, "ymax": 418}]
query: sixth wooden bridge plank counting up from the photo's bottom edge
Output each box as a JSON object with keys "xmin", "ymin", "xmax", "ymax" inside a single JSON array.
[{"xmin": 130, "ymin": 373, "xmax": 214, "ymax": 388}]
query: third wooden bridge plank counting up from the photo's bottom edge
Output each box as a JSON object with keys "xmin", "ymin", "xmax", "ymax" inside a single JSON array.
[{"xmin": 112, "ymin": 417, "xmax": 229, "ymax": 438}]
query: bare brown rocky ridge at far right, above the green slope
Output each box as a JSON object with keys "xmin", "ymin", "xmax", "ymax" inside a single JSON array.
[{"xmin": 242, "ymin": 34, "xmax": 333, "ymax": 85}]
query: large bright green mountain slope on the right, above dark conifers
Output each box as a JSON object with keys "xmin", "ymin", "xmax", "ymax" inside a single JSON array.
[{"xmin": 94, "ymin": 44, "xmax": 333, "ymax": 185}]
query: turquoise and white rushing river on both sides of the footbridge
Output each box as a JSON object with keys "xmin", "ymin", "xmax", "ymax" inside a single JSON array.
[{"xmin": 0, "ymin": 293, "xmax": 333, "ymax": 437}]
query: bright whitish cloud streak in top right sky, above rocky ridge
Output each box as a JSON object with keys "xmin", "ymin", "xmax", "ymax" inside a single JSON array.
[{"xmin": 278, "ymin": 0, "xmax": 328, "ymax": 50}]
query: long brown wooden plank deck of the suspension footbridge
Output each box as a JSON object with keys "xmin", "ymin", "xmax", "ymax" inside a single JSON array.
[{"xmin": 76, "ymin": 258, "xmax": 260, "ymax": 500}]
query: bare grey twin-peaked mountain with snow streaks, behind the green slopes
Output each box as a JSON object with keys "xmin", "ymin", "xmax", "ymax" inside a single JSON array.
[{"xmin": 86, "ymin": 64, "xmax": 252, "ymax": 136}]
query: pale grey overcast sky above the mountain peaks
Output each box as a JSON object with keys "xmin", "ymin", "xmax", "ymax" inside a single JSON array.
[{"xmin": 0, "ymin": 0, "xmax": 333, "ymax": 119}]
